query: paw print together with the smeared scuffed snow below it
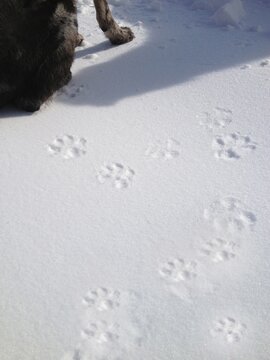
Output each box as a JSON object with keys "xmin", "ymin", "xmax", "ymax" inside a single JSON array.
[{"xmin": 158, "ymin": 258, "xmax": 215, "ymax": 301}]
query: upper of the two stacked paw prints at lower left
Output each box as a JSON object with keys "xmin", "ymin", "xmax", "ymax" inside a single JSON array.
[{"xmin": 83, "ymin": 288, "xmax": 120, "ymax": 311}]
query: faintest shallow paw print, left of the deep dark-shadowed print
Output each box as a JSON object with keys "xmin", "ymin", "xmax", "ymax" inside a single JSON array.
[{"xmin": 145, "ymin": 139, "xmax": 180, "ymax": 159}]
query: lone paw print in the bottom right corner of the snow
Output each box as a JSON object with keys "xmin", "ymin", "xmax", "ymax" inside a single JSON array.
[{"xmin": 210, "ymin": 317, "xmax": 247, "ymax": 343}]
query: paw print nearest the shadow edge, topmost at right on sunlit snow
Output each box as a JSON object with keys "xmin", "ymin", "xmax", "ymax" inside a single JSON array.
[{"xmin": 199, "ymin": 107, "xmax": 233, "ymax": 132}]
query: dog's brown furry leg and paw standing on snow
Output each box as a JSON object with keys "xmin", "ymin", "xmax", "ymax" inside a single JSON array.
[{"xmin": 94, "ymin": 0, "xmax": 134, "ymax": 45}]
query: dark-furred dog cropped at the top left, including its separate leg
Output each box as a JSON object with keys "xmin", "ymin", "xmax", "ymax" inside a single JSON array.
[{"xmin": 0, "ymin": 0, "xmax": 134, "ymax": 112}]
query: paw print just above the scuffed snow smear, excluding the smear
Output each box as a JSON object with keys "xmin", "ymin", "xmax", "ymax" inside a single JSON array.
[{"xmin": 159, "ymin": 259, "xmax": 197, "ymax": 282}]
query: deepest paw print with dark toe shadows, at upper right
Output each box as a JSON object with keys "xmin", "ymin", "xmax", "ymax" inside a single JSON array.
[{"xmin": 212, "ymin": 133, "xmax": 257, "ymax": 161}]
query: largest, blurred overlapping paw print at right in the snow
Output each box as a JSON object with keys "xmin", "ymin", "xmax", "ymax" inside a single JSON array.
[{"xmin": 204, "ymin": 197, "xmax": 256, "ymax": 233}]
